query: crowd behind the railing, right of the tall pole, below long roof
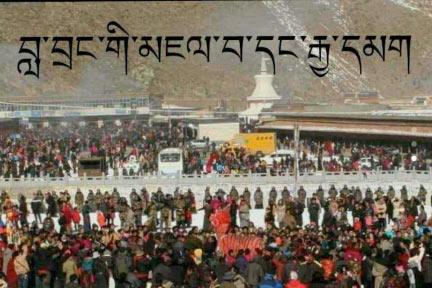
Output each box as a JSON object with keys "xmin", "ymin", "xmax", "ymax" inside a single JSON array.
[{"xmin": 275, "ymin": 137, "xmax": 432, "ymax": 172}]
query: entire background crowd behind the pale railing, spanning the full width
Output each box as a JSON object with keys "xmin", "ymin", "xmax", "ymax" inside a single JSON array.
[{"xmin": 0, "ymin": 121, "xmax": 431, "ymax": 178}]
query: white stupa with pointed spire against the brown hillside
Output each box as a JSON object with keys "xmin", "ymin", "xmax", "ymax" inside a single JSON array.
[{"xmin": 240, "ymin": 55, "xmax": 281, "ymax": 120}]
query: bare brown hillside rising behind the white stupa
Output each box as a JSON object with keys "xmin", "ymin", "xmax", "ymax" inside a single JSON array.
[{"xmin": 0, "ymin": 0, "xmax": 432, "ymax": 110}]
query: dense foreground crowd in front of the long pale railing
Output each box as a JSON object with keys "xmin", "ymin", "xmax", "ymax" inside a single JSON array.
[{"xmin": 0, "ymin": 186, "xmax": 432, "ymax": 288}]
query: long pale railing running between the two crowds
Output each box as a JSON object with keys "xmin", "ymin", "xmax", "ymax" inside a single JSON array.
[{"xmin": 0, "ymin": 170, "xmax": 432, "ymax": 189}]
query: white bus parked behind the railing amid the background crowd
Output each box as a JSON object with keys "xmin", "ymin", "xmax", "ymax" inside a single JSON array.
[{"xmin": 158, "ymin": 148, "xmax": 183, "ymax": 175}]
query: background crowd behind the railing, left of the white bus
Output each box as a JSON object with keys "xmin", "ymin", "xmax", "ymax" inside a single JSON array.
[{"xmin": 0, "ymin": 122, "xmax": 182, "ymax": 178}]
